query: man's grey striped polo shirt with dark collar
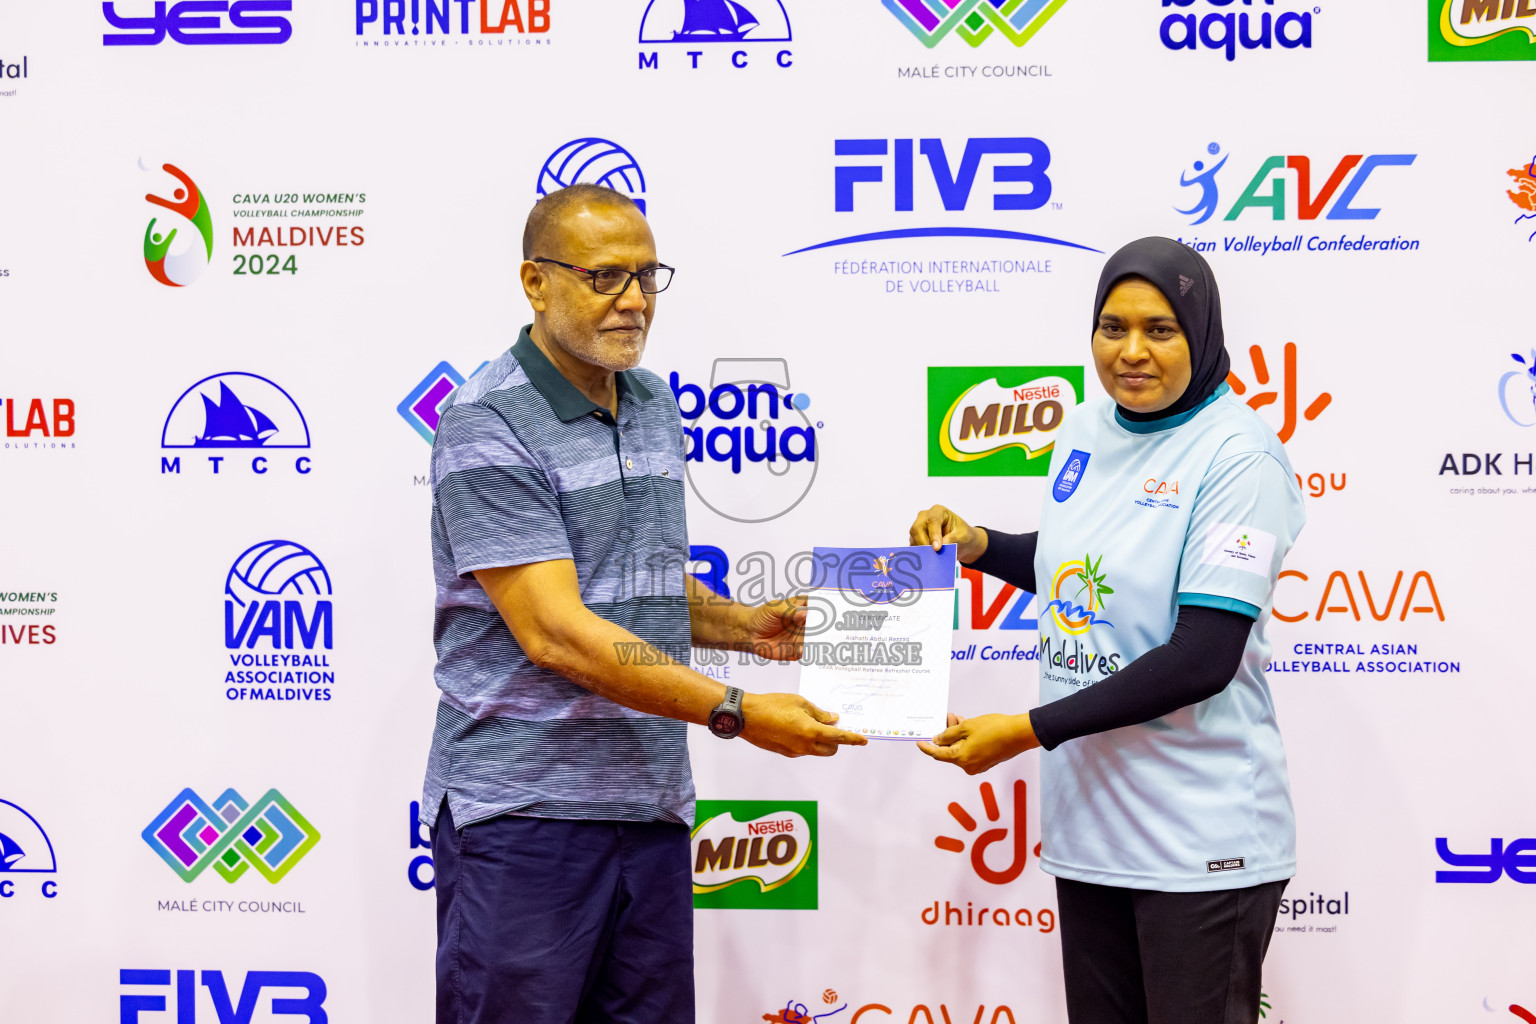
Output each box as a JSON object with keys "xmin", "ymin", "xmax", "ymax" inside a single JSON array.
[{"xmin": 421, "ymin": 327, "xmax": 693, "ymax": 826}]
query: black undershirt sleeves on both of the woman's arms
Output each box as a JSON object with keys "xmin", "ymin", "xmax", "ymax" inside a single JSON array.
[{"xmin": 971, "ymin": 530, "xmax": 1253, "ymax": 751}]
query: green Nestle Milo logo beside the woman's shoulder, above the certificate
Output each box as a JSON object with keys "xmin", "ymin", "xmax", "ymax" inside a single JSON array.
[{"xmin": 928, "ymin": 367, "xmax": 1083, "ymax": 476}]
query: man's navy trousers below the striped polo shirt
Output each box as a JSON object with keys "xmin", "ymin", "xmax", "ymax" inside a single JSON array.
[{"xmin": 432, "ymin": 804, "xmax": 694, "ymax": 1024}]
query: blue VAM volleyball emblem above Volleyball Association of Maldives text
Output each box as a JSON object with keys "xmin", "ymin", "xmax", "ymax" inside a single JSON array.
[{"xmin": 224, "ymin": 540, "xmax": 332, "ymax": 651}]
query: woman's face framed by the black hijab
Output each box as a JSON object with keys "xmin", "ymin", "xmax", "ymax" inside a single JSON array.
[{"xmin": 1094, "ymin": 278, "xmax": 1192, "ymax": 413}]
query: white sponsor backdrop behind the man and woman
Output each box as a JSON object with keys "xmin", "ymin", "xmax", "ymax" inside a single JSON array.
[{"xmin": 0, "ymin": 0, "xmax": 1536, "ymax": 1024}]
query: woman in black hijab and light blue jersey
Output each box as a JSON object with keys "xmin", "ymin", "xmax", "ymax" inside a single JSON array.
[{"xmin": 911, "ymin": 238, "xmax": 1306, "ymax": 1024}]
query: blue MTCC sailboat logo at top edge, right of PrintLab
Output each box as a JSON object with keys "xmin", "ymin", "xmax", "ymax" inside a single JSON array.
[{"xmin": 641, "ymin": 0, "xmax": 794, "ymax": 71}]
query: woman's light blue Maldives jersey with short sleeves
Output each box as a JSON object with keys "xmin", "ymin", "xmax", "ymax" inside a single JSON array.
[{"xmin": 1035, "ymin": 384, "xmax": 1306, "ymax": 892}]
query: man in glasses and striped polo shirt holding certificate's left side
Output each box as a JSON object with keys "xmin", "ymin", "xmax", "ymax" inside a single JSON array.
[{"xmin": 421, "ymin": 184, "xmax": 865, "ymax": 1024}]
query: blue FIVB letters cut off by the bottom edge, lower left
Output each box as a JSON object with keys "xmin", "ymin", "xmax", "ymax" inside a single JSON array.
[{"xmin": 118, "ymin": 970, "xmax": 330, "ymax": 1024}]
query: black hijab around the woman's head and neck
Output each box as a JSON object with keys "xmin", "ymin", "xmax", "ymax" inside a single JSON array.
[{"xmin": 1092, "ymin": 235, "xmax": 1232, "ymax": 422}]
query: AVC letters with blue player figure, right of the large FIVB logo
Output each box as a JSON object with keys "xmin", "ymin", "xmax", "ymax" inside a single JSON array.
[{"xmin": 1174, "ymin": 143, "xmax": 1418, "ymax": 224}]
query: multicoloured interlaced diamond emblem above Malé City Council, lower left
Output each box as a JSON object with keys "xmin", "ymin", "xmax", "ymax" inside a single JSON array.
[{"xmin": 141, "ymin": 789, "xmax": 319, "ymax": 884}]
